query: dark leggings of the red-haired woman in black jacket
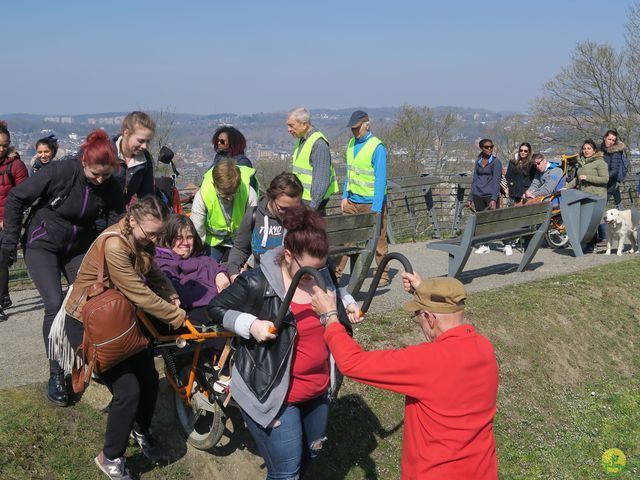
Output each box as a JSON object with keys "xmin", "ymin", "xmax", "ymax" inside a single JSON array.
[{"xmin": 24, "ymin": 248, "xmax": 84, "ymax": 374}]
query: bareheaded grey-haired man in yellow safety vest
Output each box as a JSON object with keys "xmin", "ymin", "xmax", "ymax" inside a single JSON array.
[{"xmin": 287, "ymin": 107, "xmax": 338, "ymax": 213}]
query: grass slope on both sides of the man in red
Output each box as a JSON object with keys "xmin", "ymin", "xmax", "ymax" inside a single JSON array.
[{"xmin": 306, "ymin": 261, "xmax": 640, "ymax": 480}]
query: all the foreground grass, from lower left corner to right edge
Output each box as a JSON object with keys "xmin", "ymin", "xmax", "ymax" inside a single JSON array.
[{"xmin": 0, "ymin": 260, "xmax": 640, "ymax": 480}]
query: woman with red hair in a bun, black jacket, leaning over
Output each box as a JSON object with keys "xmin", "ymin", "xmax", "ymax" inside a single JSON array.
[{"xmin": 0, "ymin": 130, "xmax": 124, "ymax": 406}]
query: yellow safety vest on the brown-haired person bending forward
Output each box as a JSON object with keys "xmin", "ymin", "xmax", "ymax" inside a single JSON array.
[{"xmin": 200, "ymin": 166, "xmax": 256, "ymax": 247}]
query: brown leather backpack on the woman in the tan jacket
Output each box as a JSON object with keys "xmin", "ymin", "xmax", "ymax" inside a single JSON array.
[{"xmin": 72, "ymin": 232, "xmax": 149, "ymax": 393}]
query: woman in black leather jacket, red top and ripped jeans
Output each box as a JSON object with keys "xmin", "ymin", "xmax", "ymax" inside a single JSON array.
[{"xmin": 208, "ymin": 206, "xmax": 359, "ymax": 479}]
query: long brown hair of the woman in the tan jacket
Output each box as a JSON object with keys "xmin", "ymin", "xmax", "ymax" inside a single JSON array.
[{"xmin": 121, "ymin": 195, "xmax": 169, "ymax": 276}]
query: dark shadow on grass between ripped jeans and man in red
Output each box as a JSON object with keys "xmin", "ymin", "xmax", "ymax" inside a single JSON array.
[{"xmin": 304, "ymin": 394, "xmax": 403, "ymax": 480}]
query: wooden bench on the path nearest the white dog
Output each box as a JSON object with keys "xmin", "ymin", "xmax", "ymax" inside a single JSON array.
[{"xmin": 427, "ymin": 202, "xmax": 551, "ymax": 277}]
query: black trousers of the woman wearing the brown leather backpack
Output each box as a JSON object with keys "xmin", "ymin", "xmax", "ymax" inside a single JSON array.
[{"xmin": 65, "ymin": 315, "xmax": 158, "ymax": 460}]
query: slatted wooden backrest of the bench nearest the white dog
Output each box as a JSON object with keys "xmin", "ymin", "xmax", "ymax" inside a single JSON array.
[{"xmin": 473, "ymin": 202, "xmax": 551, "ymax": 237}]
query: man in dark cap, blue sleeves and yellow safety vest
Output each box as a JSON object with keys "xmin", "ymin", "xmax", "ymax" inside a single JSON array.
[{"xmin": 336, "ymin": 110, "xmax": 391, "ymax": 287}]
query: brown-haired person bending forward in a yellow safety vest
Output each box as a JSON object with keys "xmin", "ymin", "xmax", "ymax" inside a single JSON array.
[{"xmin": 191, "ymin": 159, "xmax": 258, "ymax": 262}]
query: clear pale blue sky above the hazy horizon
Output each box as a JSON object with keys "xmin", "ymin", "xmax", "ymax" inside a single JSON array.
[{"xmin": 0, "ymin": 0, "xmax": 634, "ymax": 114}]
